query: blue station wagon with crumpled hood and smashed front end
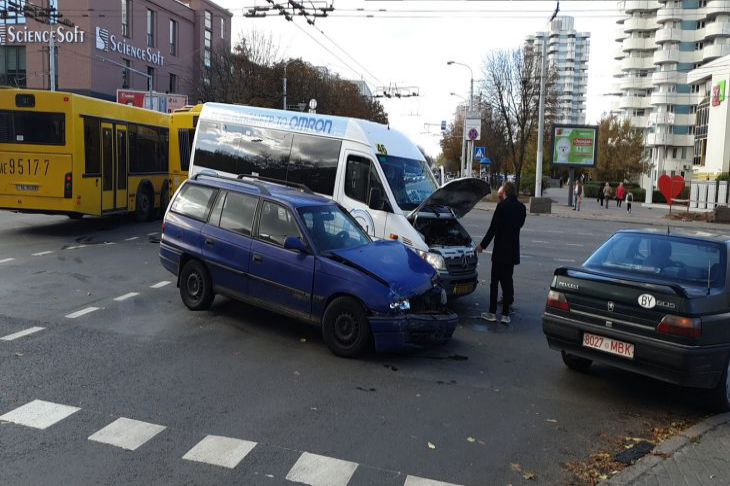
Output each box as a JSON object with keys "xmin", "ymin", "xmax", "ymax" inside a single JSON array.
[{"xmin": 160, "ymin": 173, "xmax": 458, "ymax": 357}]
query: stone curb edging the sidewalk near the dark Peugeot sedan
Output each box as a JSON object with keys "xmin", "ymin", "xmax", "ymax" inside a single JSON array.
[{"xmin": 598, "ymin": 412, "xmax": 730, "ymax": 486}]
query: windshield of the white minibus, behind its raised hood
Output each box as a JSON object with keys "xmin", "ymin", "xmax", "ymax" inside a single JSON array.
[{"xmin": 378, "ymin": 155, "xmax": 438, "ymax": 210}]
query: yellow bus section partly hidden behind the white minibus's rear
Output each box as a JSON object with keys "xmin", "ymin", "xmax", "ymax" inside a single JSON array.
[{"xmin": 168, "ymin": 105, "xmax": 198, "ymax": 194}]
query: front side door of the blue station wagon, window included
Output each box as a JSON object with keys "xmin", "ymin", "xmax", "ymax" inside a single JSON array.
[{"xmin": 249, "ymin": 200, "xmax": 315, "ymax": 317}]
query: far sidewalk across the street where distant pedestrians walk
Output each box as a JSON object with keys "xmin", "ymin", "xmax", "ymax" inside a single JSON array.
[{"xmin": 476, "ymin": 187, "xmax": 730, "ymax": 232}]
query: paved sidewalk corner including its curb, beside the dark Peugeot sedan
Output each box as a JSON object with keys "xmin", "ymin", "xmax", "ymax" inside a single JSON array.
[{"xmin": 601, "ymin": 413, "xmax": 730, "ymax": 486}]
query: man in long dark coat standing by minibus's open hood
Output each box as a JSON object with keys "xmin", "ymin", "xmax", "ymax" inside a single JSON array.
[{"xmin": 477, "ymin": 182, "xmax": 527, "ymax": 324}]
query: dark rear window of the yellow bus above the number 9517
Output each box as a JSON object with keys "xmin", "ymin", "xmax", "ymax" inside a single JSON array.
[{"xmin": 0, "ymin": 110, "xmax": 66, "ymax": 145}]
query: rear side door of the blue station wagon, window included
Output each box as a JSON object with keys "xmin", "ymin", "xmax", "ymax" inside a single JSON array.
[{"xmin": 203, "ymin": 191, "xmax": 258, "ymax": 298}]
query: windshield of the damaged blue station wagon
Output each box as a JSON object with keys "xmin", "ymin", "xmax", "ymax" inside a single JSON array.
[{"xmin": 298, "ymin": 204, "xmax": 371, "ymax": 251}]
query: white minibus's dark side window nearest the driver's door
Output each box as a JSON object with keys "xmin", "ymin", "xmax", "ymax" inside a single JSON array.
[{"xmin": 286, "ymin": 134, "xmax": 342, "ymax": 196}]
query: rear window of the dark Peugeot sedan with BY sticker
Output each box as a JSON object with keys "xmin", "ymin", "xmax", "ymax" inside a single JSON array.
[{"xmin": 584, "ymin": 233, "xmax": 725, "ymax": 288}]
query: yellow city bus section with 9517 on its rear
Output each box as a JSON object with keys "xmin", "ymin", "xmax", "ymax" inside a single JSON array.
[{"xmin": 0, "ymin": 89, "xmax": 170, "ymax": 220}]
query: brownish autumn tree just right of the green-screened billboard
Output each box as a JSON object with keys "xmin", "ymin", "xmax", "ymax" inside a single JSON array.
[{"xmin": 594, "ymin": 115, "xmax": 650, "ymax": 182}]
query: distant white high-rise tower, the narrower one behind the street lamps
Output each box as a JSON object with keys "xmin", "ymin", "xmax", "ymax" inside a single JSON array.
[{"xmin": 525, "ymin": 17, "xmax": 591, "ymax": 124}]
